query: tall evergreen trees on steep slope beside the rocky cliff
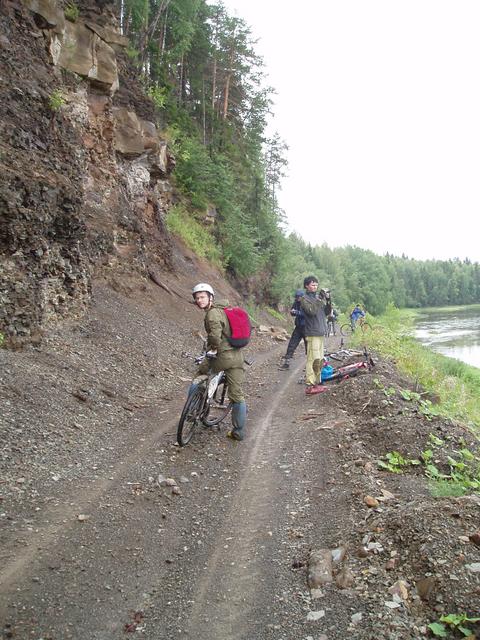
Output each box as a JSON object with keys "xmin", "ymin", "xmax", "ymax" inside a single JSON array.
[{"xmin": 118, "ymin": 0, "xmax": 286, "ymax": 286}]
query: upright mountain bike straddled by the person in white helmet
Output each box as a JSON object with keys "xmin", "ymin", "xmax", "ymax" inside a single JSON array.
[{"xmin": 177, "ymin": 351, "xmax": 232, "ymax": 447}]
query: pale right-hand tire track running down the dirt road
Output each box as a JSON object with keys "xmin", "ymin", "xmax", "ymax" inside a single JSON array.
[{"xmin": 180, "ymin": 365, "xmax": 324, "ymax": 640}]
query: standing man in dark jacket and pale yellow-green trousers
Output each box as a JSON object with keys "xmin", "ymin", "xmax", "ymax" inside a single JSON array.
[{"xmin": 300, "ymin": 276, "xmax": 332, "ymax": 395}]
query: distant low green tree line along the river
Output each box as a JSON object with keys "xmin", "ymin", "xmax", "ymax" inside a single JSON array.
[{"xmin": 279, "ymin": 234, "xmax": 480, "ymax": 315}]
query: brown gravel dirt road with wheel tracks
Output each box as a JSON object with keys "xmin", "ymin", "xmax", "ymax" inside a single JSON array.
[{"xmin": 0, "ymin": 330, "xmax": 350, "ymax": 638}]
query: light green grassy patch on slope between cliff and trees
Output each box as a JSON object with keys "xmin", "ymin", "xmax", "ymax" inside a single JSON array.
[{"xmin": 166, "ymin": 205, "xmax": 223, "ymax": 269}]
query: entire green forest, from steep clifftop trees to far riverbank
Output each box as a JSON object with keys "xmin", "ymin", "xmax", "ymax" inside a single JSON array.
[{"xmin": 118, "ymin": 0, "xmax": 480, "ymax": 314}]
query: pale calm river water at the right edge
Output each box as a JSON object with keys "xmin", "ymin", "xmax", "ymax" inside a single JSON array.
[{"xmin": 414, "ymin": 305, "xmax": 480, "ymax": 368}]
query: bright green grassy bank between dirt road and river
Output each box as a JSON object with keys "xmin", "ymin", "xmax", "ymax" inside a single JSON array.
[{"xmin": 352, "ymin": 307, "xmax": 480, "ymax": 435}]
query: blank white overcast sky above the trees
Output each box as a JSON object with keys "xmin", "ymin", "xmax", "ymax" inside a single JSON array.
[{"xmin": 219, "ymin": 0, "xmax": 480, "ymax": 261}]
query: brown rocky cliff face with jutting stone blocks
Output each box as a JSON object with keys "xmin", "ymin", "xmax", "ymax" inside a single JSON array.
[{"xmin": 0, "ymin": 0, "xmax": 173, "ymax": 345}]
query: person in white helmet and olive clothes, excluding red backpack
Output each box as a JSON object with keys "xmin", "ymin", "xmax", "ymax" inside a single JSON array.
[{"xmin": 192, "ymin": 282, "xmax": 247, "ymax": 440}]
